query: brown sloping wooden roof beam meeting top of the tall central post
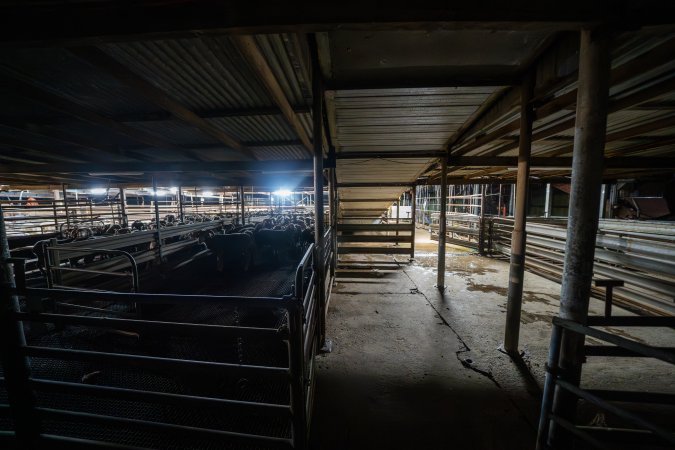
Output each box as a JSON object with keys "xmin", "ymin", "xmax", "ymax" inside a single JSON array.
[{"xmin": 233, "ymin": 35, "xmax": 314, "ymax": 155}]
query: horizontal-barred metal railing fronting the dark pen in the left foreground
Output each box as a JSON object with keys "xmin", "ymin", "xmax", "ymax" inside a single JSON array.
[{"xmin": 0, "ymin": 239, "xmax": 328, "ymax": 449}]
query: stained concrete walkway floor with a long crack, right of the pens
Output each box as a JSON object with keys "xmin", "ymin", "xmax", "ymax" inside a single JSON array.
[{"xmin": 311, "ymin": 229, "xmax": 675, "ymax": 450}]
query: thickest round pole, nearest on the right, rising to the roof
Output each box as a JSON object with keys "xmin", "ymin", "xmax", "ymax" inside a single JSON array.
[{"xmin": 552, "ymin": 30, "xmax": 611, "ymax": 448}]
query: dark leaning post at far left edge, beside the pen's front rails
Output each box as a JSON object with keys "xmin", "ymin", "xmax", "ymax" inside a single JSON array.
[{"xmin": 0, "ymin": 206, "xmax": 40, "ymax": 450}]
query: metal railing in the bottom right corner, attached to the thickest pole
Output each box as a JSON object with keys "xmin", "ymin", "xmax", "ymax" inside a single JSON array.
[{"xmin": 537, "ymin": 316, "xmax": 675, "ymax": 450}]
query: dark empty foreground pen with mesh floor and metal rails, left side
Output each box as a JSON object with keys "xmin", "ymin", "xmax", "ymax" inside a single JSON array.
[{"xmin": 0, "ymin": 206, "xmax": 334, "ymax": 449}]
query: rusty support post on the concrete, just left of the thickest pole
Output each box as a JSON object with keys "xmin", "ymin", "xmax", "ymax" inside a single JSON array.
[{"xmin": 504, "ymin": 74, "xmax": 534, "ymax": 354}]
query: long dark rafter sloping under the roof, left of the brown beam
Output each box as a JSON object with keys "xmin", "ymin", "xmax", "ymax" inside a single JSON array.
[{"xmin": 70, "ymin": 47, "xmax": 256, "ymax": 159}]
